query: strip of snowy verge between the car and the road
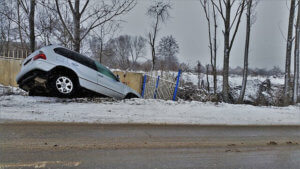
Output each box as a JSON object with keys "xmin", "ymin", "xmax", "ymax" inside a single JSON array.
[{"xmin": 0, "ymin": 95, "xmax": 300, "ymax": 125}]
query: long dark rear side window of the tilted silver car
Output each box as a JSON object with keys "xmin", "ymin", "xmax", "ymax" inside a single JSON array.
[{"xmin": 54, "ymin": 48, "xmax": 97, "ymax": 71}]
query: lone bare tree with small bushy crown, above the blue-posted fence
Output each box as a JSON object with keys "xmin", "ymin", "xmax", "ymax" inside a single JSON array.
[{"xmin": 147, "ymin": 1, "xmax": 171, "ymax": 70}]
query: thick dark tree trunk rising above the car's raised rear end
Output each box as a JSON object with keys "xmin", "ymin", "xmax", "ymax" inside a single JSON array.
[{"xmin": 29, "ymin": 0, "xmax": 36, "ymax": 52}]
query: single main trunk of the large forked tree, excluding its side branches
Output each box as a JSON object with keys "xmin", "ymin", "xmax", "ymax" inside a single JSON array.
[{"xmin": 223, "ymin": 0, "xmax": 231, "ymax": 103}]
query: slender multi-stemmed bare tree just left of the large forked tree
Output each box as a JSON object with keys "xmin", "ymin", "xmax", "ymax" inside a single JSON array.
[{"xmin": 200, "ymin": 0, "xmax": 218, "ymax": 94}]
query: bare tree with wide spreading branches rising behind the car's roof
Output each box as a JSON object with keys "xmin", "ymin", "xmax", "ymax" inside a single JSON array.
[{"xmin": 55, "ymin": 0, "xmax": 136, "ymax": 52}]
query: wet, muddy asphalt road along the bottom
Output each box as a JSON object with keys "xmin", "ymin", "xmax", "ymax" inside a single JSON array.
[{"xmin": 0, "ymin": 122, "xmax": 300, "ymax": 169}]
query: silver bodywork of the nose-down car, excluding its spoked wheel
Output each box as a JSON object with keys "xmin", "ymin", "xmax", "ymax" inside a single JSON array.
[{"xmin": 16, "ymin": 45, "xmax": 141, "ymax": 99}]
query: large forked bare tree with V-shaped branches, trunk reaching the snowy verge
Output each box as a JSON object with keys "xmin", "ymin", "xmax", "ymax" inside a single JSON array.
[{"xmin": 211, "ymin": 0, "xmax": 245, "ymax": 102}]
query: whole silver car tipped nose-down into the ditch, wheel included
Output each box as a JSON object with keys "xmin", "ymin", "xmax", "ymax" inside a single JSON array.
[{"xmin": 16, "ymin": 45, "xmax": 141, "ymax": 99}]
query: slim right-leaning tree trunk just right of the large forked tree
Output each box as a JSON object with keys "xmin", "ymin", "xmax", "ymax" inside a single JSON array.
[{"xmin": 238, "ymin": 0, "xmax": 252, "ymax": 103}]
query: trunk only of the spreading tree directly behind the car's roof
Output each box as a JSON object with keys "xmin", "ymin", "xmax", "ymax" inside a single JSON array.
[{"xmin": 73, "ymin": 0, "xmax": 80, "ymax": 52}]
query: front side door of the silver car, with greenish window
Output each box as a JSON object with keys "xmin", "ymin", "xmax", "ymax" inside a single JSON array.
[{"xmin": 95, "ymin": 62, "xmax": 125, "ymax": 98}]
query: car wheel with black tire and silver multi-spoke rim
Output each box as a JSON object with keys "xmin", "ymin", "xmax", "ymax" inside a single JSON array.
[{"xmin": 49, "ymin": 73, "xmax": 78, "ymax": 98}]
